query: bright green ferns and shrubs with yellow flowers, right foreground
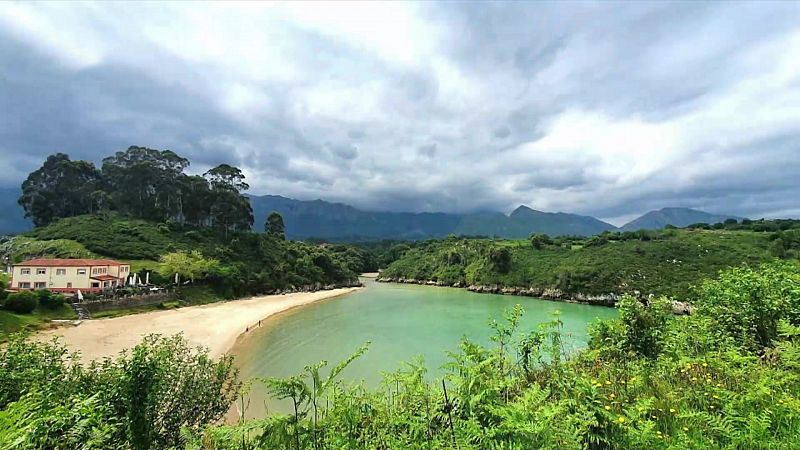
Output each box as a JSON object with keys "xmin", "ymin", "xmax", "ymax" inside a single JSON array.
[{"xmin": 195, "ymin": 264, "xmax": 800, "ymax": 450}]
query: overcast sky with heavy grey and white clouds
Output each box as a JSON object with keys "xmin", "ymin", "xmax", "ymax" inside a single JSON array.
[{"xmin": 0, "ymin": 2, "xmax": 800, "ymax": 225}]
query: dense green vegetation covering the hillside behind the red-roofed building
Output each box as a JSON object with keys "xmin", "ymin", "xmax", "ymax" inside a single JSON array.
[{"xmin": 9, "ymin": 213, "xmax": 361, "ymax": 298}]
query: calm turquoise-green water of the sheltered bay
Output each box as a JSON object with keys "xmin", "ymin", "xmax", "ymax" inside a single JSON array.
[{"xmin": 235, "ymin": 279, "xmax": 617, "ymax": 416}]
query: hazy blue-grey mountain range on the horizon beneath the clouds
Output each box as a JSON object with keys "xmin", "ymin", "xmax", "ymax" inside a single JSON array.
[{"xmin": 0, "ymin": 188, "xmax": 740, "ymax": 241}]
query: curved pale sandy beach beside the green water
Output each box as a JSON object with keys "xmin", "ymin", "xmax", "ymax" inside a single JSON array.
[{"xmin": 37, "ymin": 288, "xmax": 360, "ymax": 361}]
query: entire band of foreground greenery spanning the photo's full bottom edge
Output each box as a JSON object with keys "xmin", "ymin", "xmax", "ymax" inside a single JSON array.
[{"xmin": 0, "ymin": 262, "xmax": 800, "ymax": 450}]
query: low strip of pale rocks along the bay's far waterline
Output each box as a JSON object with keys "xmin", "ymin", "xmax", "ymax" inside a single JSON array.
[{"xmin": 376, "ymin": 276, "xmax": 692, "ymax": 314}]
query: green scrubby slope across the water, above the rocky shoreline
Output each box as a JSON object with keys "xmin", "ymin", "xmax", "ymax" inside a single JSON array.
[{"xmin": 383, "ymin": 230, "xmax": 771, "ymax": 298}]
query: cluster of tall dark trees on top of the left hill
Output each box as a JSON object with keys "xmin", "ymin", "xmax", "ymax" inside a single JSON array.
[{"xmin": 19, "ymin": 146, "xmax": 253, "ymax": 231}]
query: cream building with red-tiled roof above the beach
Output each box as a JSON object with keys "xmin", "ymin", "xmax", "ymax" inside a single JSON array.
[{"xmin": 10, "ymin": 258, "xmax": 131, "ymax": 293}]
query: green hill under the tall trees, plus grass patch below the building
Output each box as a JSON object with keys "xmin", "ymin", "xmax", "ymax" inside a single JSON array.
[{"xmin": 0, "ymin": 213, "xmax": 366, "ymax": 339}]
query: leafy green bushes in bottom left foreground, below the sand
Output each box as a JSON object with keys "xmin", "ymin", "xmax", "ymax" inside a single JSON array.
[{"xmin": 0, "ymin": 336, "xmax": 239, "ymax": 450}]
